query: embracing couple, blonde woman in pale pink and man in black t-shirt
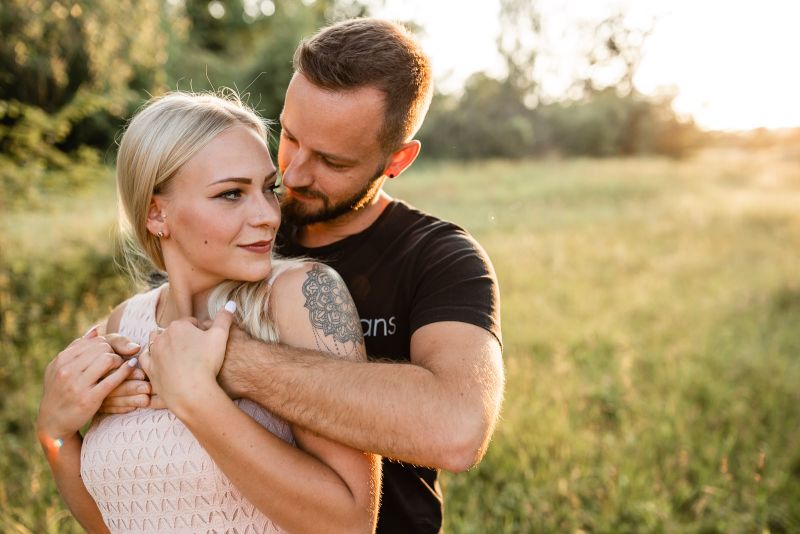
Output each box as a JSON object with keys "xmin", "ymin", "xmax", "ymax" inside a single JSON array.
[{"xmin": 37, "ymin": 19, "xmax": 504, "ymax": 533}]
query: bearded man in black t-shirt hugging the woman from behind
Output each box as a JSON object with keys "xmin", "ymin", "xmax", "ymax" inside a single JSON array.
[{"xmin": 106, "ymin": 19, "xmax": 504, "ymax": 533}]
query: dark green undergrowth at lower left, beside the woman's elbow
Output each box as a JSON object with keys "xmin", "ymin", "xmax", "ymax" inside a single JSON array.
[{"xmin": 0, "ymin": 241, "xmax": 130, "ymax": 533}]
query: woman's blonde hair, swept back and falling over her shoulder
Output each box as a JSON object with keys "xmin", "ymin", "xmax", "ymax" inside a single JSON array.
[{"xmin": 116, "ymin": 90, "xmax": 298, "ymax": 341}]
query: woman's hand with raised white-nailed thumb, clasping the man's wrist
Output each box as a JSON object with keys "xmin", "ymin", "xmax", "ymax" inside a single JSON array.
[{"xmin": 140, "ymin": 302, "xmax": 236, "ymax": 418}]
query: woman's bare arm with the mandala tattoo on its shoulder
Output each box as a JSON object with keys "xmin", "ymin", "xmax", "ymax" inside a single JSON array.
[{"xmin": 142, "ymin": 266, "xmax": 380, "ymax": 532}]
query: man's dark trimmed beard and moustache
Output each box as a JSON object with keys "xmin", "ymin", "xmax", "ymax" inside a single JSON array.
[{"xmin": 281, "ymin": 167, "xmax": 383, "ymax": 226}]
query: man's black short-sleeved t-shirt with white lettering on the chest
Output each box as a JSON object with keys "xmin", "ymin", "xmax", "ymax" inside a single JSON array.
[{"xmin": 277, "ymin": 200, "xmax": 501, "ymax": 533}]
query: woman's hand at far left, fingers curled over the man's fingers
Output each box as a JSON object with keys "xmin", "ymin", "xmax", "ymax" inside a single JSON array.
[{"xmin": 36, "ymin": 328, "xmax": 139, "ymax": 443}]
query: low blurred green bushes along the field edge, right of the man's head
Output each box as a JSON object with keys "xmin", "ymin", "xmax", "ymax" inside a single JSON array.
[{"xmin": 419, "ymin": 81, "xmax": 701, "ymax": 159}]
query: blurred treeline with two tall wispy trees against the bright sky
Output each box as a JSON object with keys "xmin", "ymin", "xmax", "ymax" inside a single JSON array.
[{"xmin": 420, "ymin": 0, "xmax": 701, "ymax": 159}]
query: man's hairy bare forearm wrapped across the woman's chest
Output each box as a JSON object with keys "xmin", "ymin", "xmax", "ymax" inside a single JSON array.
[{"xmin": 224, "ymin": 340, "xmax": 494, "ymax": 471}]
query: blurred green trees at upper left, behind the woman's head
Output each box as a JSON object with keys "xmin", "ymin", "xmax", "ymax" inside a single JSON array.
[{"xmin": 0, "ymin": 0, "xmax": 378, "ymax": 209}]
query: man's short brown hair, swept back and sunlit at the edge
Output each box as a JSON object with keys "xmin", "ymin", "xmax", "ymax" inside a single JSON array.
[{"xmin": 294, "ymin": 18, "xmax": 432, "ymax": 154}]
